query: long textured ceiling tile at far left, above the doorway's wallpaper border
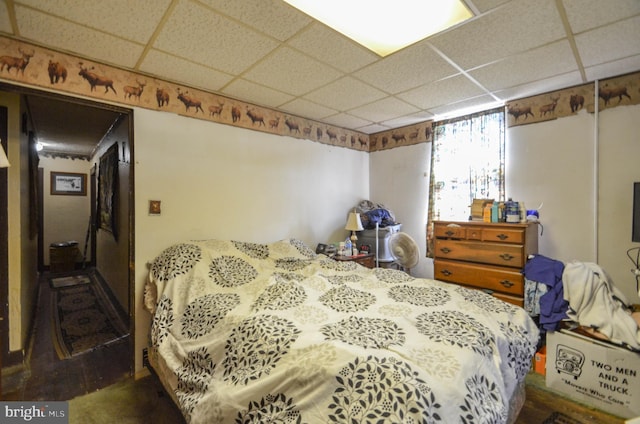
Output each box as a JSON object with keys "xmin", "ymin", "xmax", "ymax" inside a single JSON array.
[{"xmin": 15, "ymin": 5, "xmax": 143, "ymax": 68}]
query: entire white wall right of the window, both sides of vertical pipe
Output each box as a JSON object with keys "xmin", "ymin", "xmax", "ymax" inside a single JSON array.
[{"xmin": 506, "ymin": 105, "xmax": 640, "ymax": 303}]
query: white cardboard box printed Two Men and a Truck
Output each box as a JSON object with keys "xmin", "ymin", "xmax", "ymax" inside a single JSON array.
[{"xmin": 546, "ymin": 329, "xmax": 640, "ymax": 418}]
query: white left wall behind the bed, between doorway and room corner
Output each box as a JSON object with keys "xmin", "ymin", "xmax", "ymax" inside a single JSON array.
[{"xmin": 133, "ymin": 109, "xmax": 369, "ymax": 370}]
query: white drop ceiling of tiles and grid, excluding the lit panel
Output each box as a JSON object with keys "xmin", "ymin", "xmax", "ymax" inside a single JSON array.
[{"xmin": 0, "ymin": 0, "xmax": 640, "ymax": 156}]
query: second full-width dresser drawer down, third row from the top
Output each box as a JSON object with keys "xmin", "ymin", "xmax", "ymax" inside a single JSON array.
[{"xmin": 433, "ymin": 259, "xmax": 524, "ymax": 297}]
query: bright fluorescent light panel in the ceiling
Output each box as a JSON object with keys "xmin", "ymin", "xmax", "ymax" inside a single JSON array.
[{"xmin": 284, "ymin": 0, "xmax": 473, "ymax": 57}]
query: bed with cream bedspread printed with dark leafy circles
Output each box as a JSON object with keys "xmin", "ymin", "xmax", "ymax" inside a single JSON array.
[{"xmin": 144, "ymin": 239, "xmax": 539, "ymax": 423}]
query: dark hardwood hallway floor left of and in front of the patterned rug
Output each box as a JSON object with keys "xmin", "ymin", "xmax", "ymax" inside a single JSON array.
[{"xmin": 2, "ymin": 273, "xmax": 131, "ymax": 401}]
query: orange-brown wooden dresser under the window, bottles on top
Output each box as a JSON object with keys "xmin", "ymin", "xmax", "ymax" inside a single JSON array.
[{"xmin": 434, "ymin": 221, "xmax": 538, "ymax": 307}]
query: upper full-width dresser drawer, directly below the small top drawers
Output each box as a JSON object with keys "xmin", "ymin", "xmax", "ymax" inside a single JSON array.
[{"xmin": 434, "ymin": 239, "xmax": 525, "ymax": 268}]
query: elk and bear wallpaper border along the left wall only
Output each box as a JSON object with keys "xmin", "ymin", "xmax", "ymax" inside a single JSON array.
[{"xmin": 0, "ymin": 36, "xmax": 369, "ymax": 151}]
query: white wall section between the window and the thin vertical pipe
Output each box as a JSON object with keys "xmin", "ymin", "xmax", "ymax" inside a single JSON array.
[{"xmin": 505, "ymin": 111, "xmax": 596, "ymax": 262}]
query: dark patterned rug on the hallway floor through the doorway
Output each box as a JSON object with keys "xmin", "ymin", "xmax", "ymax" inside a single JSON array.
[{"xmin": 51, "ymin": 276, "xmax": 128, "ymax": 359}]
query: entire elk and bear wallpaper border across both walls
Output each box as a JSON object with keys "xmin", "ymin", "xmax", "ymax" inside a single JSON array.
[{"xmin": 0, "ymin": 35, "xmax": 640, "ymax": 152}]
